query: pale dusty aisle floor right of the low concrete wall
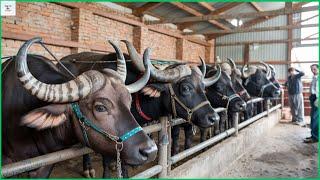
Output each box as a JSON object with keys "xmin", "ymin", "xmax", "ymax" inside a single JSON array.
[{"xmin": 219, "ymin": 116, "xmax": 318, "ymax": 177}]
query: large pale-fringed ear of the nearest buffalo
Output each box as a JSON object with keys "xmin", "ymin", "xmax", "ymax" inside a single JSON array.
[{"xmin": 21, "ymin": 104, "xmax": 68, "ymax": 130}]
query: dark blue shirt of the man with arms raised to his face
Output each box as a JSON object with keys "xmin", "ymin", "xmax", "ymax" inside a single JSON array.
[{"xmin": 285, "ymin": 70, "xmax": 304, "ymax": 95}]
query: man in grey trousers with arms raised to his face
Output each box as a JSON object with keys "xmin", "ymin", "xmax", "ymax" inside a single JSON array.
[{"xmin": 285, "ymin": 67, "xmax": 306, "ymax": 127}]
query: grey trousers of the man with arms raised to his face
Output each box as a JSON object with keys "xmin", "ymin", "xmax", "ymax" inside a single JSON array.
[{"xmin": 289, "ymin": 93, "xmax": 304, "ymax": 122}]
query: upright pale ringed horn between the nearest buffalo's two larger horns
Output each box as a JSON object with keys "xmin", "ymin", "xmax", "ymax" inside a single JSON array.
[{"xmin": 108, "ymin": 40, "xmax": 127, "ymax": 83}]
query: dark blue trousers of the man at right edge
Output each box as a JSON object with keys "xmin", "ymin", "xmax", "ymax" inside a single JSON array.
[{"xmin": 309, "ymin": 95, "xmax": 319, "ymax": 139}]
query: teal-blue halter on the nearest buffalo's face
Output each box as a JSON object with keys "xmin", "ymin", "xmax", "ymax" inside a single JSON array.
[{"xmin": 71, "ymin": 103, "xmax": 142, "ymax": 147}]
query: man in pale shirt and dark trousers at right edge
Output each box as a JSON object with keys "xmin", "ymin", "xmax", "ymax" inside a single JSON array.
[{"xmin": 304, "ymin": 64, "xmax": 319, "ymax": 143}]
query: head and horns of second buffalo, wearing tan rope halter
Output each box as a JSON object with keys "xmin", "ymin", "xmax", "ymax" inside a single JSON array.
[{"xmin": 123, "ymin": 41, "xmax": 220, "ymax": 127}]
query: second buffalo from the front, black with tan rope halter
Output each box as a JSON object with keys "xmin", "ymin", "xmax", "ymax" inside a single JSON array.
[{"xmin": 59, "ymin": 41, "xmax": 220, "ymax": 177}]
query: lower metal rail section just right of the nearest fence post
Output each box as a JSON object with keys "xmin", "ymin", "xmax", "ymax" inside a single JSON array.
[{"xmin": 170, "ymin": 128, "xmax": 235, "ymax": 164}]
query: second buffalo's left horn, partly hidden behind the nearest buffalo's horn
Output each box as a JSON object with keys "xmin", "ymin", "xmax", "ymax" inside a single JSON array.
[{"xmin": 122, "ymin": 40, "xmax": 191, "ymax": 82}]
